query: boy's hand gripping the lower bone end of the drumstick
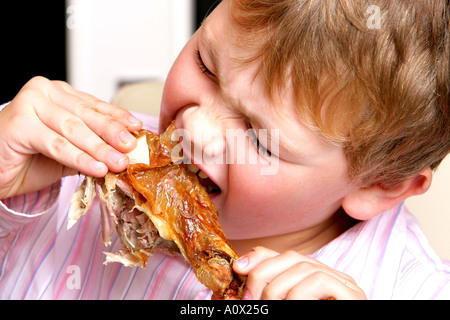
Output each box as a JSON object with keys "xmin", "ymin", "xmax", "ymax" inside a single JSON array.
[{"xmin": 233, "ymin": 247, "xmax": 366, "ymax": 300}]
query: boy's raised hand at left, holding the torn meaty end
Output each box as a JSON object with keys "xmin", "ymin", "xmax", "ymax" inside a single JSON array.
[{"xmin": 0, "ymin": 77, "xmax": 142, "ymax": 199}]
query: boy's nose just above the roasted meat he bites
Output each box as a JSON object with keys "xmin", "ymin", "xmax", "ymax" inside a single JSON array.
[{"xmin": 181, "ymin": 106, "xmax": 226, "ymax": 163}]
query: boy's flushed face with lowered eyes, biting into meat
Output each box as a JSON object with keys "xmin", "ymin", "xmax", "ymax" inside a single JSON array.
[{"xmin": 160, "ymin": 1, "xmax": 352, "ymax": 239}]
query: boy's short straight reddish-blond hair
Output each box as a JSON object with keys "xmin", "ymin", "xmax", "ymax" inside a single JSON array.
[{"xmin": 230, "ymin": 0, "xmax": 450, "ymax": 188}]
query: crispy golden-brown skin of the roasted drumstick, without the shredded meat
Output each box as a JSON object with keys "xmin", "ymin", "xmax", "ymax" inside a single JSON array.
[{"xmin": 126, "ymin": 124, "xmax": 245, "ymax": 299}]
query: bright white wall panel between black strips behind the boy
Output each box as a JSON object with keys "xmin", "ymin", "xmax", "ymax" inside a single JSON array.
[{"xmin": 66, "ymin": 0, "xmax": 194, "ymax": 101}]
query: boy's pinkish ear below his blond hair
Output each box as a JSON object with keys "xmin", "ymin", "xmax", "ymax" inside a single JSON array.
[{"xmin": 342, "ymin": 167, "xmax": 432, "ymax": 220}]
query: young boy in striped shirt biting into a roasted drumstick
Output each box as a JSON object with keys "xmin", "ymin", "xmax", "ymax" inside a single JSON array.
[{"xmin": 0, "ymin": 0, "xmax": 450, "ymax": 299}]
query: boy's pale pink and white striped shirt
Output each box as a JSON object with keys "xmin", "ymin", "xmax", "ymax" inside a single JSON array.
[{"xmin": 0, "ymin": 111, "xmax": 450, "ymax": 299}]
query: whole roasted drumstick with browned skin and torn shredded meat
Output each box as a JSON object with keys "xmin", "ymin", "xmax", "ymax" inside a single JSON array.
[{"xmin": 68, "ymin": 123, "xmax": 245, "ymax": 299}]
